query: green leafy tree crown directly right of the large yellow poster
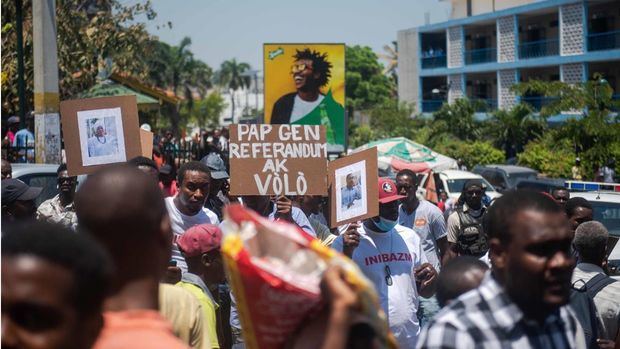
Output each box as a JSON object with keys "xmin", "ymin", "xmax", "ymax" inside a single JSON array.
[{"xmin": 345, "ymin": 45, "xmax": 396, "ymax": 110}]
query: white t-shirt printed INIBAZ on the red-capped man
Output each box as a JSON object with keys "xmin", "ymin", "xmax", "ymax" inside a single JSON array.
[{"xmin": 332, "ymin": 225, "xmax": 427, "ymax": 348}]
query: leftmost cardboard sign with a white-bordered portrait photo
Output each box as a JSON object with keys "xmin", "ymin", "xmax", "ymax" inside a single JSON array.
[{"xmin": 60, "ymin": 96, "xmax": 142, "ymax": 176}]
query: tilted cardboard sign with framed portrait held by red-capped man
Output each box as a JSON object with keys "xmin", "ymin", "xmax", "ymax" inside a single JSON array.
[{"xmin": 328, "ymin": 147, "xmax": 379, "ymax": 228}]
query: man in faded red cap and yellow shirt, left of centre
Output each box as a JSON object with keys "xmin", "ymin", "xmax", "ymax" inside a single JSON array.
[{"xmin": 177, "ymin": 224, "xmax": 226, "ymax": 348}]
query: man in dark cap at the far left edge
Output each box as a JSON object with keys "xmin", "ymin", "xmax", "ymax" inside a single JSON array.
[{"xmin": 2, "ymin": 178, "xmax": 43, "ymax": 227}]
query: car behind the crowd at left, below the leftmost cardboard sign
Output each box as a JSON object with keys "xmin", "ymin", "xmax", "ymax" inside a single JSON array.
[{"xmin": 11, "ymin": 164, "xmax": 86, "ymax": 206}]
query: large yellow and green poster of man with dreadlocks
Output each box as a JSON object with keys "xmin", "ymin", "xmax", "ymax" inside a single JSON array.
[{"xmin": 264, "ymin": 44, "xmax": 346, "ymax": 150}]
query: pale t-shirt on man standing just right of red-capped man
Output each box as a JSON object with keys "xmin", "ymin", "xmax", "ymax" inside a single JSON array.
[{"xmin": 398, "ymin": 200, "xmax": 448, "ymax": 270}]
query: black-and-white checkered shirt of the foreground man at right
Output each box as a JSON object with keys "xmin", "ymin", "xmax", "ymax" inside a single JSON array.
[{"xmin": 418, "ymin": 273, "xmax": 586, "ymax": 349}]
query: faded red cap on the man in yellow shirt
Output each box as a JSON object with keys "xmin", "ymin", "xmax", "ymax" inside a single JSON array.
[{"xmin": 177, "ymin": 224, "xmax": 222, "ymax": 257}]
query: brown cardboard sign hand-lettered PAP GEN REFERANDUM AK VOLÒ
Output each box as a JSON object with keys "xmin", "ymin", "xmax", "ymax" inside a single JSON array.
[{"xmin": 229, "ymin": 124, "xmax": 327, "ymax": 195}]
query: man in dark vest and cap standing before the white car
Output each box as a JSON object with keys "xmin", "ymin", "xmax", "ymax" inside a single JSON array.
[{"xmin": 444, "ymin": 179, "xmax": 489, "ymax": 262}]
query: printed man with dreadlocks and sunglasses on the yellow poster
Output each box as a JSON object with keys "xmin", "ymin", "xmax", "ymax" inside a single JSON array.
[{"xmin": 271, "ymin": 49, "xmax": 332, "ymax": 124}]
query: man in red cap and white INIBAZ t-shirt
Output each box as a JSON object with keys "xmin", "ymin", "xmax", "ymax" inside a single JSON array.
[{"xmin": 332, "ymin": 178, "xmax": 437, "ymax": 348}]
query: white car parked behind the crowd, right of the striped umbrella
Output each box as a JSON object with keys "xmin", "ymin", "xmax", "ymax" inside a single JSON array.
[{"xmin": 418, "ymin": 170, "xmax": 501, "ymax": 200}]
